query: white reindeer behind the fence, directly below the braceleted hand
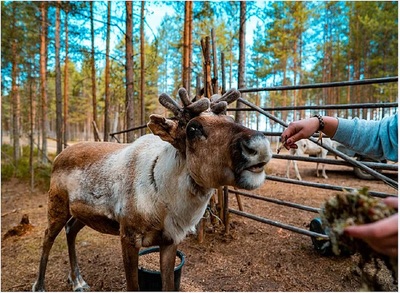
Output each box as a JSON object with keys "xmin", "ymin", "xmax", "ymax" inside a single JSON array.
[{"xmin": 286, "ymin": 137, "xmax": 333, "ymax": 180}]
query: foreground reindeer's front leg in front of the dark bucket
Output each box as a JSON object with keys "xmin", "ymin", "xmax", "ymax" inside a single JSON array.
[{"xmin": 160, "ymin": 244, "xmax": 177, "ymax": 291}]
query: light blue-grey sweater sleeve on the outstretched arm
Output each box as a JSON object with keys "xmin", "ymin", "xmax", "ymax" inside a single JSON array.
[{"xmin": 332, "ymin": 113, "xmax": 398, "ymax": 162}]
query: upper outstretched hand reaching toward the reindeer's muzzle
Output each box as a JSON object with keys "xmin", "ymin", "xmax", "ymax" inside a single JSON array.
[{"xmin": 281, "ymin": 117, "xmax": 319, "ymax": 150}]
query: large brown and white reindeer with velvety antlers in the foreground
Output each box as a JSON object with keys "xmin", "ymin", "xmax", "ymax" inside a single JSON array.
[{"xmin": 33, "ymin": 89, "xmax": 272, "ymax": 291}]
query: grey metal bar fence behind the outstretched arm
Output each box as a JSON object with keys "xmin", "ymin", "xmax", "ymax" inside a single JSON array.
[{"xmin": 222, "ymin": 77, "xmax": 398, "ymax": 239}]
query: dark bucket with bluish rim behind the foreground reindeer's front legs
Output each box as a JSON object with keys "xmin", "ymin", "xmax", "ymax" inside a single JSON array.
[{"xmin": 139, "ymin": 246, "xmax": 185, "ymax": 291}]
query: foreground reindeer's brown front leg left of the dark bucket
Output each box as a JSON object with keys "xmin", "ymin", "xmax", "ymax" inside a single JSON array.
[{"xmin": 121, "ymin": 225, "xmax": 140, "ymax": 291}]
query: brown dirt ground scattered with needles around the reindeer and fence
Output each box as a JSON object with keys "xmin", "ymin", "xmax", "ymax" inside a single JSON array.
[{"xmin": 1, "ymin": 154, "xmax": 397, "ymax": 292}]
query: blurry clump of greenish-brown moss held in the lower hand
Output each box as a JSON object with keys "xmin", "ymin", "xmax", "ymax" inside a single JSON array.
[{"xmin": 320, "ymin": 188, "xmax": 398, "ymax": 291}]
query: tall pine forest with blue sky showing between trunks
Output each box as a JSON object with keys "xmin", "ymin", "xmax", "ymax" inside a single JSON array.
[{"xmin": 1, "ymin": 1, "xmax": 398, "ymax": 180}]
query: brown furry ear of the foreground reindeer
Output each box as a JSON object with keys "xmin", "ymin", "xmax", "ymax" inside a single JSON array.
[{"xmin": 147, "ymin": 114, "xmax": 178, "ymax": 144}]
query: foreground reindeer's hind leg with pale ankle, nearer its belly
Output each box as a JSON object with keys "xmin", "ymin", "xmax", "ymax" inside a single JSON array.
[{"xmin": 65, "ymin": 217, "xmax": 90, "ymax": 292}]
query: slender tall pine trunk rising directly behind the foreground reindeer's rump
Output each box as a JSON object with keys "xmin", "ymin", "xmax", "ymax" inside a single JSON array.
[{"xmin": 55, "ymin": 1, "xmax": 62, "ymax": 154}]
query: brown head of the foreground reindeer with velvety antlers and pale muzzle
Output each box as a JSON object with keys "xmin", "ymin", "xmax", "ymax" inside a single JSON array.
[{"xmin": 147, "ymin": 88, "xmax": 272, "ymax": 189}]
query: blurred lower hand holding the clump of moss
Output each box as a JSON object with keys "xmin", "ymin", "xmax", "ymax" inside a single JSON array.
[{"xmin": 344, "ymin": 197, "xmax": 398, "ymax": 256}]
